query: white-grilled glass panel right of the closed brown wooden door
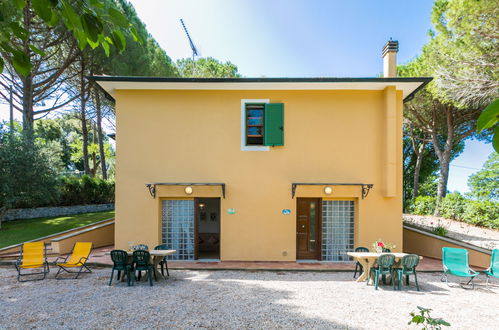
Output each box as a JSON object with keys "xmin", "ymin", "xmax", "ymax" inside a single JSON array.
[{"xmin": 322, "ymin": 200, "xmax": 355, "ymax": 261}]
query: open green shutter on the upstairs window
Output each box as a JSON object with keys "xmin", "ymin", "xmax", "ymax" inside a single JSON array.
[{"xmin": 263, "ymin": 103, "xmax": 284, "ymax": 146}]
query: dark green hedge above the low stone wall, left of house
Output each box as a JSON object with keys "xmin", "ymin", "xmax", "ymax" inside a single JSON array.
[{"xmin": 58, "ymin": 175, "xmax": 114, "ymax": 205}]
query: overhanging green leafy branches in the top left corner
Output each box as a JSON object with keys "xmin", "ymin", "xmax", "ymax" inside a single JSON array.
[{"xmin": 0, "ymin": 0, "xmax": 142, "ymax": 77}]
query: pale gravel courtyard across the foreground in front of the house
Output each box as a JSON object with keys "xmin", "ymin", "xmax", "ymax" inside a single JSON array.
[{"xmin": 0, "ymin": 267, "xmax": 499, "ymax": 329}]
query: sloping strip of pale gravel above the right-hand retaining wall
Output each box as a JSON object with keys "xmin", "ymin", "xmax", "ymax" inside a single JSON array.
[{"xmin": 404, "ymin": 214, "xmax": 499, "ymax": 250}]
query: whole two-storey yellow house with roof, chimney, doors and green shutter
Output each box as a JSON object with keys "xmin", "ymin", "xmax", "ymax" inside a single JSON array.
[{"xmin": 90, "ymin": 42, "xmax": 431, "ymax": 262}]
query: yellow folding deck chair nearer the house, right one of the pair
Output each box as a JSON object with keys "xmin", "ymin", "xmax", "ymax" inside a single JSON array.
[{"xmin": 55, "ymin": 242, "xmax": 92, "ymax": 280}]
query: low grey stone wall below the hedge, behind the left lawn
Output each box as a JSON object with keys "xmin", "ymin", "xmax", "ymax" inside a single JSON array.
[{"xmin": 4, "ymin": 203, "xmax": 114, "ymax": 221}]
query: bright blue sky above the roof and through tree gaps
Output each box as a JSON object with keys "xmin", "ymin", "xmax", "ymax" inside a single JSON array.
[{"xmin": 0, "ymin": 0, "xmax": 493, "ymax": 192}]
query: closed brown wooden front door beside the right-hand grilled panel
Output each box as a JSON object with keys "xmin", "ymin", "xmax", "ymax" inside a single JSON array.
[{"xmin": 296, "ymin": 198, "xmax": 322, "ymax": 259}]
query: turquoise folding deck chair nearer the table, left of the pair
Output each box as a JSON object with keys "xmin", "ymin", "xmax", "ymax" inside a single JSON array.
[{"xmin": 442, "ymin": 247, "xmax": 478, "ymax": 289}]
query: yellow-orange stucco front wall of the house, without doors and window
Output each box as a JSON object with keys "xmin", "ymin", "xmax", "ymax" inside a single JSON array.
[{"xmin": 115, "ymin": 88, "xmax": 402, "ymax": 261}]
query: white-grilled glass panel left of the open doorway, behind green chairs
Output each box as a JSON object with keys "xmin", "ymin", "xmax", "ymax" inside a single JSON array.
[{"xmin": 162, "ymin": 199, "xmax": 195, "ymax": 260}]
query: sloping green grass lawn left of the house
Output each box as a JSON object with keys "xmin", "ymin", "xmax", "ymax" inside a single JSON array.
[{"xmin": 0, "ymin": 211, "xmax": 114, "ymax": 248}]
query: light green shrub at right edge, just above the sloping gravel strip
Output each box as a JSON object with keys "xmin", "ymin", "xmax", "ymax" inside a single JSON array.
[{"xmin": 463, "ymin": 200, "xmax": 499, "ymax": 229}]
